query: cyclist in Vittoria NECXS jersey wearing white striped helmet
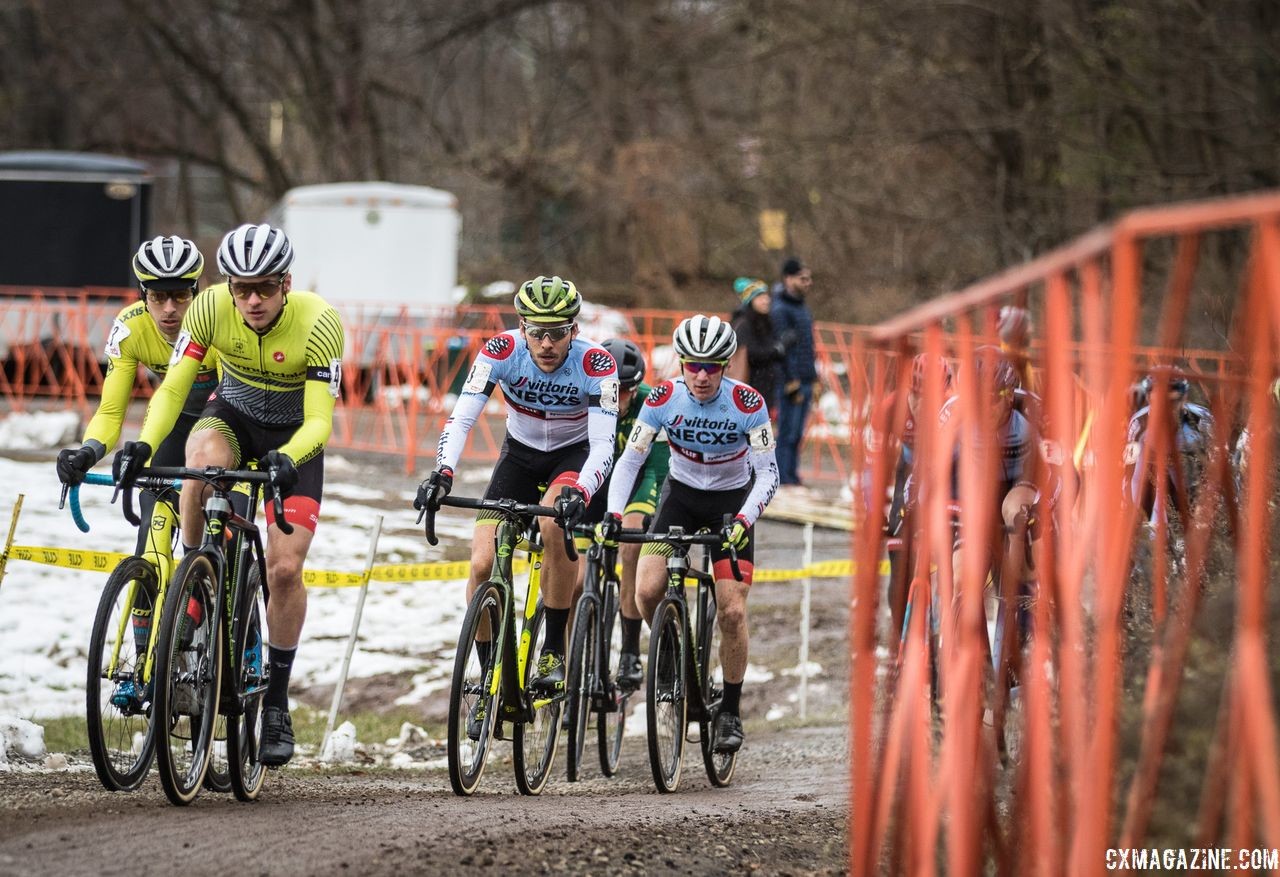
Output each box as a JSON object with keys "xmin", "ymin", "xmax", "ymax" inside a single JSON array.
[{"xmin": 598, "ymin": 314, "xmax": 778, "ymax": 752}]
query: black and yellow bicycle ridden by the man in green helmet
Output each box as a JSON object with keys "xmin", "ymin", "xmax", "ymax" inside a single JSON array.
[{"xmin": 419, "ymin": 497, "xmax": 577, "ymax": 796}]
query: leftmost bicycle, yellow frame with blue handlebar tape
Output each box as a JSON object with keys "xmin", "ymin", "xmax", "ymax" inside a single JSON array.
[{"xmin": 58, "ymin": 472, "xmax": 232, "ymax": 793}]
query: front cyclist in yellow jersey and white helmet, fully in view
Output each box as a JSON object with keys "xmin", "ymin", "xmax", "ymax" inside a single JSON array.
[{"xmin": 114, "ymin": 224, "xmax": 344, "ymax": 766}]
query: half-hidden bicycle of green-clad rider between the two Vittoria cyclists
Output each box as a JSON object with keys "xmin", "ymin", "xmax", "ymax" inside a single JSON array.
[{"xmin": 564, "ymin": 527, "xmax": 635, "ymax": 782}]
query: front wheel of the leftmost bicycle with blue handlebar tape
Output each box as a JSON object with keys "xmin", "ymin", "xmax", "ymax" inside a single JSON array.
[{"xmin": 84, "ymin": 557, "xmax": 159, "ymax": 791}]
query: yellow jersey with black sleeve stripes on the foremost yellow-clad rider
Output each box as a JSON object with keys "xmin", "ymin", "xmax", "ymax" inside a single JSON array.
[{"xmin": 140, "ymin": 283, "xmax": 346, "ymax": 465}]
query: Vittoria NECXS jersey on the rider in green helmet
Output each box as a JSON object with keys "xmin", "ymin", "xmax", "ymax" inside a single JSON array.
[{"xmin": 435, "ymin": 332, "xmax": 618, "ymax": 499}]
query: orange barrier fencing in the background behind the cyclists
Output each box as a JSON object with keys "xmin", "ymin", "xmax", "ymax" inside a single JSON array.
[{"xmin": 0, "ymin": 295, "xmax": 859, "ymax": 483}]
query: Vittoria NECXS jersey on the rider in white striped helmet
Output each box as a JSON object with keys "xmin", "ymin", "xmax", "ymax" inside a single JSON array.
[{"xmin": 608, "ymin": 378, "xmax": 778, "ymax": 525}]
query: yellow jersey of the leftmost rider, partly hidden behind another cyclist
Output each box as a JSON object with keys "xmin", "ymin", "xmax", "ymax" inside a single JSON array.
[{"xmin": 83, "ymin": 296, "xmax": 218, "ymax": 457}]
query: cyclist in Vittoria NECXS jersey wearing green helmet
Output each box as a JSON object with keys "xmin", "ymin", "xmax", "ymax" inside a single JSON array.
[{"xmin": 413, "ymin": 277, "xmax": 618, "ymax": 696}]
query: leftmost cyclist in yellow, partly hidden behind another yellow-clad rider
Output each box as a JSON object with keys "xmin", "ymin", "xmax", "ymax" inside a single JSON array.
[{"xmin": 58, "ymin": 237, "xmax": 218, "ymax": 553}]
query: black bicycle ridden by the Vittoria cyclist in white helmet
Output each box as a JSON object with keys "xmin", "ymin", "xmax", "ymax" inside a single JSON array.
[{"xmin": 618, "ymin": 515, "xmax": 742, "ymax": 793}]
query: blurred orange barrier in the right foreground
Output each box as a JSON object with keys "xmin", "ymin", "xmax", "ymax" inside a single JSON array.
[{"xmin": 850, "ymin": 193, "xmax": 1280, "ymax": 874}]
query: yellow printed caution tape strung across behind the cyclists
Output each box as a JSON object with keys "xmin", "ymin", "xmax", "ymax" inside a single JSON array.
[{"xmin": 9, "ymin": 545, "xmax": 888, "ymax": 588}]
